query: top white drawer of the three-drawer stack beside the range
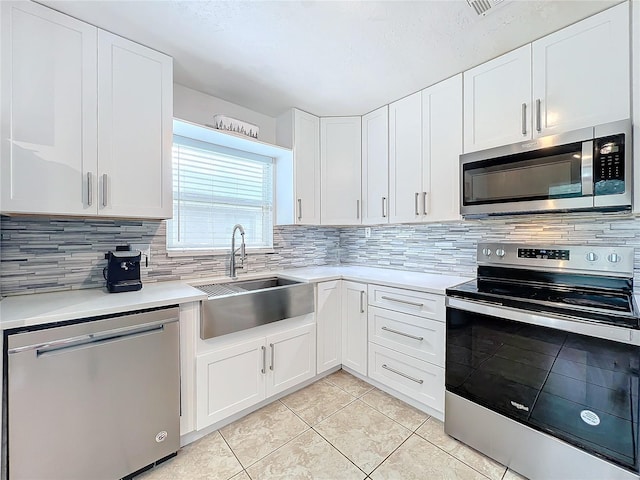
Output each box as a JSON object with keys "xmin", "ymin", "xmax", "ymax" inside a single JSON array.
[{"xmin": 368, "ymin": 285, "xmax": 445, "ymax": 322}]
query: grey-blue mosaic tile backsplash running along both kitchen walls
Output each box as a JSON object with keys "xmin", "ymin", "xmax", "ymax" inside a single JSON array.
[{"xmin": 0, "ymin": 214, "xmax": 640, "ymax": 295}]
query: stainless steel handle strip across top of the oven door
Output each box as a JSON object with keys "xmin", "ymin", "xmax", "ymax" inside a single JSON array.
[{"xmin": 446, "ymin": 297, "xmax": 640, "ymax": 346}]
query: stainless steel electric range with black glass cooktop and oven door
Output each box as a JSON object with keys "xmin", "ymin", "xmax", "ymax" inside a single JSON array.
[{"xmin": 445, "ymin": 243, "xmax": 640, "ymax": 480}]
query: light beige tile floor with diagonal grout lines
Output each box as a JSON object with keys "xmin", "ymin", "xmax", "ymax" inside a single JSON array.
[{"xmin": 136, "ymin": 370, "xmax": 523, "ymax": 480}]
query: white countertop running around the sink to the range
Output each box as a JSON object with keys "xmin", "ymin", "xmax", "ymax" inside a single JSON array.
[{"xmin": 0, "ymin": 265, "xmax": 470, "ymax": 330}]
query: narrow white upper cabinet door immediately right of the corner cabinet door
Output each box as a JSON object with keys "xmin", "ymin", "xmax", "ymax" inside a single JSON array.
[{"xmin": 362, "ymin": 105, "xmax": 389, "ymax": 225}]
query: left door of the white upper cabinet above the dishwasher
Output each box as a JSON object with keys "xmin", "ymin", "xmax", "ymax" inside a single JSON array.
[{"xmin": 0, "ymin": 2, "xmax": 97, "ymax": 215}]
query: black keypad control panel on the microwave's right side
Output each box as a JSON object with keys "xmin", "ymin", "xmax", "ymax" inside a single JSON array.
[{"xmin": 593, "ymin": 135, "xmax": 625, "ymax": 195}]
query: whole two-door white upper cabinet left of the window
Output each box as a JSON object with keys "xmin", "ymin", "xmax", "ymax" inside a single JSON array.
[{"xmin": 0, "ymin": 2, "xmax": 173, "ymax": 218}]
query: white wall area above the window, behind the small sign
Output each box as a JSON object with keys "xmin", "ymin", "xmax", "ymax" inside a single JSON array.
[{"xmin": 173, "ymin": 83, "xmax": 276, "ymax": 144}]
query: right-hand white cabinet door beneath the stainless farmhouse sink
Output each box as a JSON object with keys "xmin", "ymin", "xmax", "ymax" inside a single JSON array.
[{"xmin": 267, "ymin": 323, "xmax": 316, "ymax": 397}]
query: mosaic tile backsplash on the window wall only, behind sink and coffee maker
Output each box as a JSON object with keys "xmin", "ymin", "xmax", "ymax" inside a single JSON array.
[{"xmin": 0, "ymin": 217, "xmax": 339, "ymax": 296}]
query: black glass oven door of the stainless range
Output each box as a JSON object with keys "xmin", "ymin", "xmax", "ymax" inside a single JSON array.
[{"xmin": 445, "ymin": 300, "xmax": 640, "ymax": 472}]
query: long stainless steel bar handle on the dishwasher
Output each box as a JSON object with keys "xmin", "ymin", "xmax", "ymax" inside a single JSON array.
[{"xmin": 7, "ymin": 319, "xmax": 178, "ymax": 356}]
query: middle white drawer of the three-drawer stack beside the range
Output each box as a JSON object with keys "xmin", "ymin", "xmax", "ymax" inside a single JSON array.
[{"xmin": 368, "ymin": 307, "xmax": 445, "ymax": 367}]
